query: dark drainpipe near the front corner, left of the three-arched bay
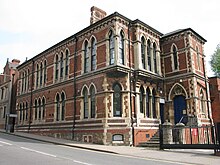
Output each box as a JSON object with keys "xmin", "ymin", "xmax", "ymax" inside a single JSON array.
[{"xmin": 128, "ymin": 22, "xmax": 135, "ymax": 146}]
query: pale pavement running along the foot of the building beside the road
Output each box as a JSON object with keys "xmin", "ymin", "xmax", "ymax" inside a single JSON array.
[{"xmin": 0, "ymin": 130, "xmax": 220, "ymax": 165}]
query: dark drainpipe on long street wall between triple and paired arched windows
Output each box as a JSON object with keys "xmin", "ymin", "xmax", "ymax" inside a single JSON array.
[{"xmin": 72, "ymin": 36, "xmax": 78, "ymax": 140}]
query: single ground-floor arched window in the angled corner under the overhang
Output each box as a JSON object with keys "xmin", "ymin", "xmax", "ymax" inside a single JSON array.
[{"xmin": 113, "ymin": 83, "xmax": 122, "ymax": 117}]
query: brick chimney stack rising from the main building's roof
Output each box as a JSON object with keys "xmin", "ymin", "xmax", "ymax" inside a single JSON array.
[{"xmin": 90, "ymin": 6, "xmax": 107, "ymax": 25}]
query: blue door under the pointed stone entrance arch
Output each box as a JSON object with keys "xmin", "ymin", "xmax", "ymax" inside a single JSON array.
[{"xmin": 173, "ymin": 95, "xmax": 186, "ymax": 124}]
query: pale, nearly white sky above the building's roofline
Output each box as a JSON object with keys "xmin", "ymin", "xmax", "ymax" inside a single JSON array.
[{"xmin": 0, "ymin": 0, "xmax": 220, "ymax": 76}]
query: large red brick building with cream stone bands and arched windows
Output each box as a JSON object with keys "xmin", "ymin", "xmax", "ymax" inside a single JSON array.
[{"xmin": 16, "ymin": 7, "xmax": 211, "ymax": 145}]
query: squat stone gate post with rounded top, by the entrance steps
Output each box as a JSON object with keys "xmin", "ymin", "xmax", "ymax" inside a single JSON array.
[{"xmin": 163, "ymin": 121, "xmax": 173, "ymax": 144}]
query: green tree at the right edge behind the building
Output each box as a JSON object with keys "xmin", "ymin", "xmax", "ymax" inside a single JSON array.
[{"xmin": 210, "ymin": 44, "xmax": 220, "ymax": 77}]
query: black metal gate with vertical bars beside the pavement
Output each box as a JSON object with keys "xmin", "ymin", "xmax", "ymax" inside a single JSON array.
[{"xmin": 160, "ymin": 124, "xmax": 220, "ymax": 153}]
